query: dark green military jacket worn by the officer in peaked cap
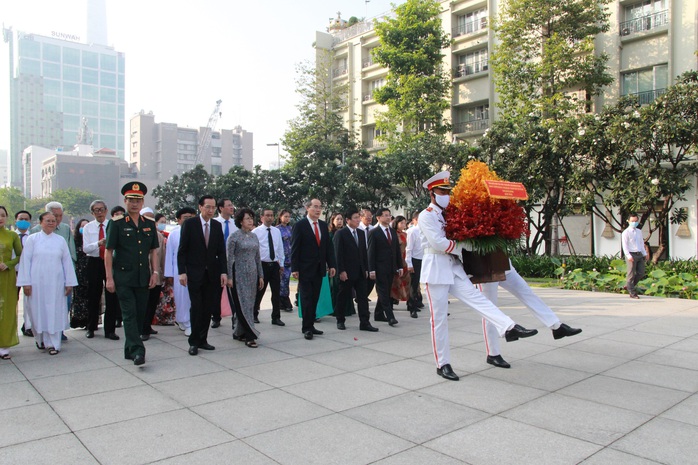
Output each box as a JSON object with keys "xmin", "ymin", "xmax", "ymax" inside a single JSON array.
[{"xmin": 106, "ymin": 216, "xmax": 162, "ymax": 287}]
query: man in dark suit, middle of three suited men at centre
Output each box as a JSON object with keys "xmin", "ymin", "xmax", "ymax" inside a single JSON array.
[{"xmin": 334, "ymin": 209, "xmax": 378, "ymax": 331}]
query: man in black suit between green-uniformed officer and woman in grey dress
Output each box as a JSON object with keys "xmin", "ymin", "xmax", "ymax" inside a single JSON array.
[{"xmin": 177, "ymin": 195, "xmax": 228, "ymax": 355}]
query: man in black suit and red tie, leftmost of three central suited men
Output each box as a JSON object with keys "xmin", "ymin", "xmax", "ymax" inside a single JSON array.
[{"xmin": 291, "ymin": 199, "xmax": 336, "ymax": 340}]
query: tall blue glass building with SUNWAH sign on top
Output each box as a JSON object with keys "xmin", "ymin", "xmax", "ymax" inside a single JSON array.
[{"xmin": 5, "ymin": 31, "xmax": 125, "ymax": 188}]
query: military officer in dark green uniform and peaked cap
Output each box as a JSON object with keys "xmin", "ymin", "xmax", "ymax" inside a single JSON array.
[{"xmin": 104, "ymin": 182, "xmax": 161, "ymax": 365}]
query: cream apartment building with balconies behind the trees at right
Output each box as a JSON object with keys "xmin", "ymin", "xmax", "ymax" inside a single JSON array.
[{"xmin": 315, "ymin": 0, "xmax": 698, "ymax": 258}]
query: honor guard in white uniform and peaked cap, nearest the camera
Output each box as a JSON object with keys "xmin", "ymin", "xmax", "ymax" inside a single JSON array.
[{"xmin": 419, "ymin": 171, "xmax": 538, "ymax": 381}]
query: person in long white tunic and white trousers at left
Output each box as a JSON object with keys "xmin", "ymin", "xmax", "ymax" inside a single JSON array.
[{"xmin": 17, "ymin": 212, "xmax": 78, "ymax": 355}]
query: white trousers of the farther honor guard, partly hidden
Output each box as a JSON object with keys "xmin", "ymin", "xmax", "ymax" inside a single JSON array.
[{"xmin": 480, "ymin": 268, "xmax": 560, "ymax": 355}]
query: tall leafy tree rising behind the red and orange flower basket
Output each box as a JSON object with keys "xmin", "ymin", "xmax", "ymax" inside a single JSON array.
[{"xmin": 482, "ymin": 0, "xmax": 612, "ymax": 254}]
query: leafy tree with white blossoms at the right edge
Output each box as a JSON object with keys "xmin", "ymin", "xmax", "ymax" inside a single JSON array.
[{"xmin": 575, "ymin": 71, "xmax": 698, "ymax": 263}]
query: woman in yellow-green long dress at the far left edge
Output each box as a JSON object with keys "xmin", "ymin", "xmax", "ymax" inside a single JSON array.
[{"xmin": 0, "ymin": 206, "xmax": 21, "ymax": 360}]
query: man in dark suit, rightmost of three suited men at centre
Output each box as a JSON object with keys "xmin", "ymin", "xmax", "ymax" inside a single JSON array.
[{"xmin": 368, "ymin": 208, "xmax": 402, "ymax": 326}]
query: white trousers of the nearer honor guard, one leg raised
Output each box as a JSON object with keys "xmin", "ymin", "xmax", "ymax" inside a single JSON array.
[{"xmin": 424, "ymin": 276, "xmax": 514, "ymax": 368}]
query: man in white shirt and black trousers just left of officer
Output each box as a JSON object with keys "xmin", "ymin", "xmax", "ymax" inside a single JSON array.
[{"xmin": 82, "ymin": 200, "xmax": 120, "ymax": 341}]
